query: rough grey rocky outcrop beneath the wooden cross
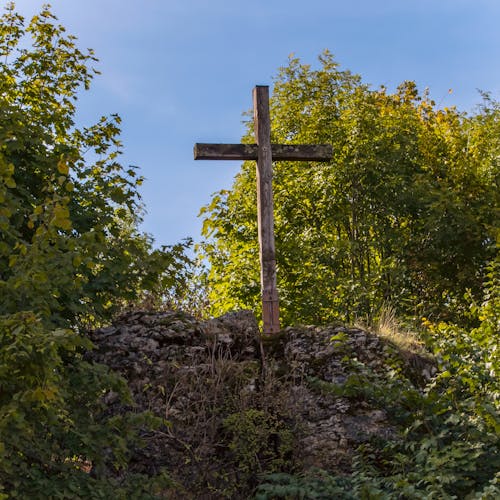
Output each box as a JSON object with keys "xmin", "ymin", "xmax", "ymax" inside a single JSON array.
[{"xmin": 89, "ymin": 311, "xmax": 429, "ymax": 498}]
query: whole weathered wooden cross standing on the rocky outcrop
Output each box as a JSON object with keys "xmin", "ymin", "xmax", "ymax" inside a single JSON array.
[{"xmin": 194, "ymin": 85, "xmax": 333, "ymax": 334}]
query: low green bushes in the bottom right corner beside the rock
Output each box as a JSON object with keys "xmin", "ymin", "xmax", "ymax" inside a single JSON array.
[{"xmin": 256, "ymin": 262, "xmax": 500, "ymax": 500}]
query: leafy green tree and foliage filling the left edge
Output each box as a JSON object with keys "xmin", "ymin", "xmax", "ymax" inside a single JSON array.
[{"xmin": 0, "ymin": 4, "xmax": 189, "ymax": 498}]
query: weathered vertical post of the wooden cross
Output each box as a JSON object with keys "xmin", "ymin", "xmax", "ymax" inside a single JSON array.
[{"xmin": 253, "ymin": 85, "xmax": 280, "ymax": 334}]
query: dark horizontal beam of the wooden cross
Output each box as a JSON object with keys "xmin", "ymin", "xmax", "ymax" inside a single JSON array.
[{"xmin": 194, "ymin": 143, "xmax": 333, "ymax": 161}]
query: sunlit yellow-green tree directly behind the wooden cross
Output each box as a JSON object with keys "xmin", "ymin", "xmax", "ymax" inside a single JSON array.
[{"xmin": 202, "ymin": 49, "xmax": 499, "ymax": 324}]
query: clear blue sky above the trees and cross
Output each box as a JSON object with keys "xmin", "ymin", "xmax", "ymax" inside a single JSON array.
[{"xmin": 8, "ymin": 0, "xmax": 500, "ymax": 245}]
